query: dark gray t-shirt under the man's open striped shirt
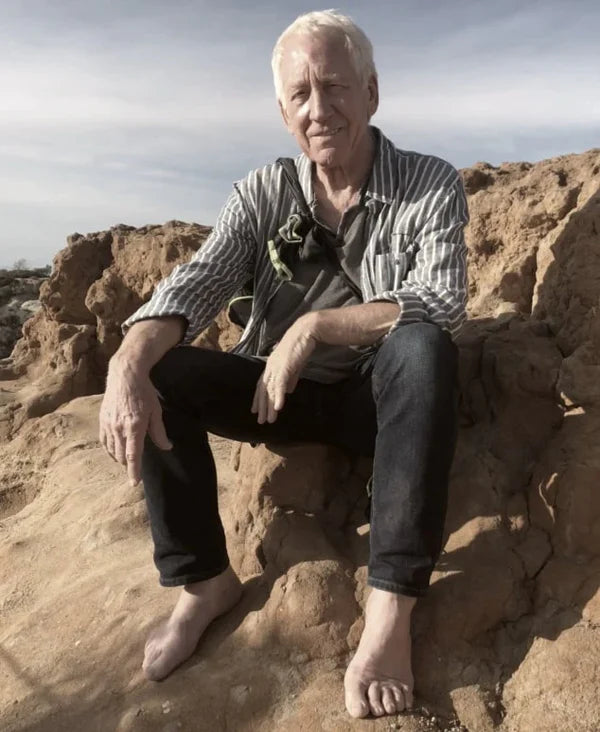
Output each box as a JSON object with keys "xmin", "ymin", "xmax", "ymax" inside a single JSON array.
[{"xmin": 261, "ymin": 204, "xmax": 375, "ymax": 383}]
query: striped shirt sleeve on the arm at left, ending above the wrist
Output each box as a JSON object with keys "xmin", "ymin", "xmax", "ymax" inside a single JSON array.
[{"xmin": 121, "ymin": 187, "xmax": 256, "ymax": 344}]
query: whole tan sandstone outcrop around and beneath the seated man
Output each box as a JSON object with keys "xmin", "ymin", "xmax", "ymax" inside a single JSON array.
[{"xmin": 0, "ymin": 151, "xmax": 600, "ymax": 732}]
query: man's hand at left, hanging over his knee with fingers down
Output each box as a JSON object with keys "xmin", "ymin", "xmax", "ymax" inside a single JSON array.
[{"xmin": 100, "ymin": 357, "xmax": 173, "ymax": 485}]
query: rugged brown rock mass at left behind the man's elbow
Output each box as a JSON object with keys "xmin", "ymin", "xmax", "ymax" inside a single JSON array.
[{"xmin": 0, "ymin": 221, "xmax": 230, "ymax": 434}]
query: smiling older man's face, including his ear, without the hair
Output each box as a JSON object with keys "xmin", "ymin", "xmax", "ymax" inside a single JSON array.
[{"xmin": 280, "ymin": 34, "xmax": 378, "ymax": 168}]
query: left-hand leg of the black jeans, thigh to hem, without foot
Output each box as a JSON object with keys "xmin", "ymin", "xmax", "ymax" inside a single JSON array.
[{"xmin": 142, "ymin": 348, "xmax": 338, "ymax": 586}]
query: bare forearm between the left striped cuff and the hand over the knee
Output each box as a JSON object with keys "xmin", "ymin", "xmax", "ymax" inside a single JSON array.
[{"xmin": 109, "ymin": 316, "xmax": 186, "ymax": 374}]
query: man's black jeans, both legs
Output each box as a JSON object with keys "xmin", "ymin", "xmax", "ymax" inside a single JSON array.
[{"xmin": 142, "ymin": 323, "xmax": 457, "ymax": 597}]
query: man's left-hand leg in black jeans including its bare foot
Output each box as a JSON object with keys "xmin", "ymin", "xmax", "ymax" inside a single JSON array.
[{"xmin": 142, "ymin": 348, "xmax": 340, "ymax": 680}]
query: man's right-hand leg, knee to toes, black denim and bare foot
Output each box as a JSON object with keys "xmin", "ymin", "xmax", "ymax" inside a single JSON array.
[{"xmin": 345, "ymin": 324, "xmax": 457, "ymax": 717}]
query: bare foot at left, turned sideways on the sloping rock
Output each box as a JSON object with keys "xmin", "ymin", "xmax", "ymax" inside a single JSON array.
[{"xmin": 142, "ymin": 567, "xmax": 242, "ymax": 681}]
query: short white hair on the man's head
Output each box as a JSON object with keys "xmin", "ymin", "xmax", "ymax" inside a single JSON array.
[{"xmin": 271, "ymin": 10, "xmax": 377, "ymax": 102}]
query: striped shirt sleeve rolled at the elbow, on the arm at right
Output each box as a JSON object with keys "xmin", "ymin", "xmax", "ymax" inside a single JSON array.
[{"xmin": 373, "ymin": 173, "xmax": 469, "ymax": 336}]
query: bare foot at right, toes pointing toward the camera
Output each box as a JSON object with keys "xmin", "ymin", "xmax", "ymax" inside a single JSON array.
[{"xmin": 344, "ymin": 588, "xmax": 416, "ymax": 717}]
